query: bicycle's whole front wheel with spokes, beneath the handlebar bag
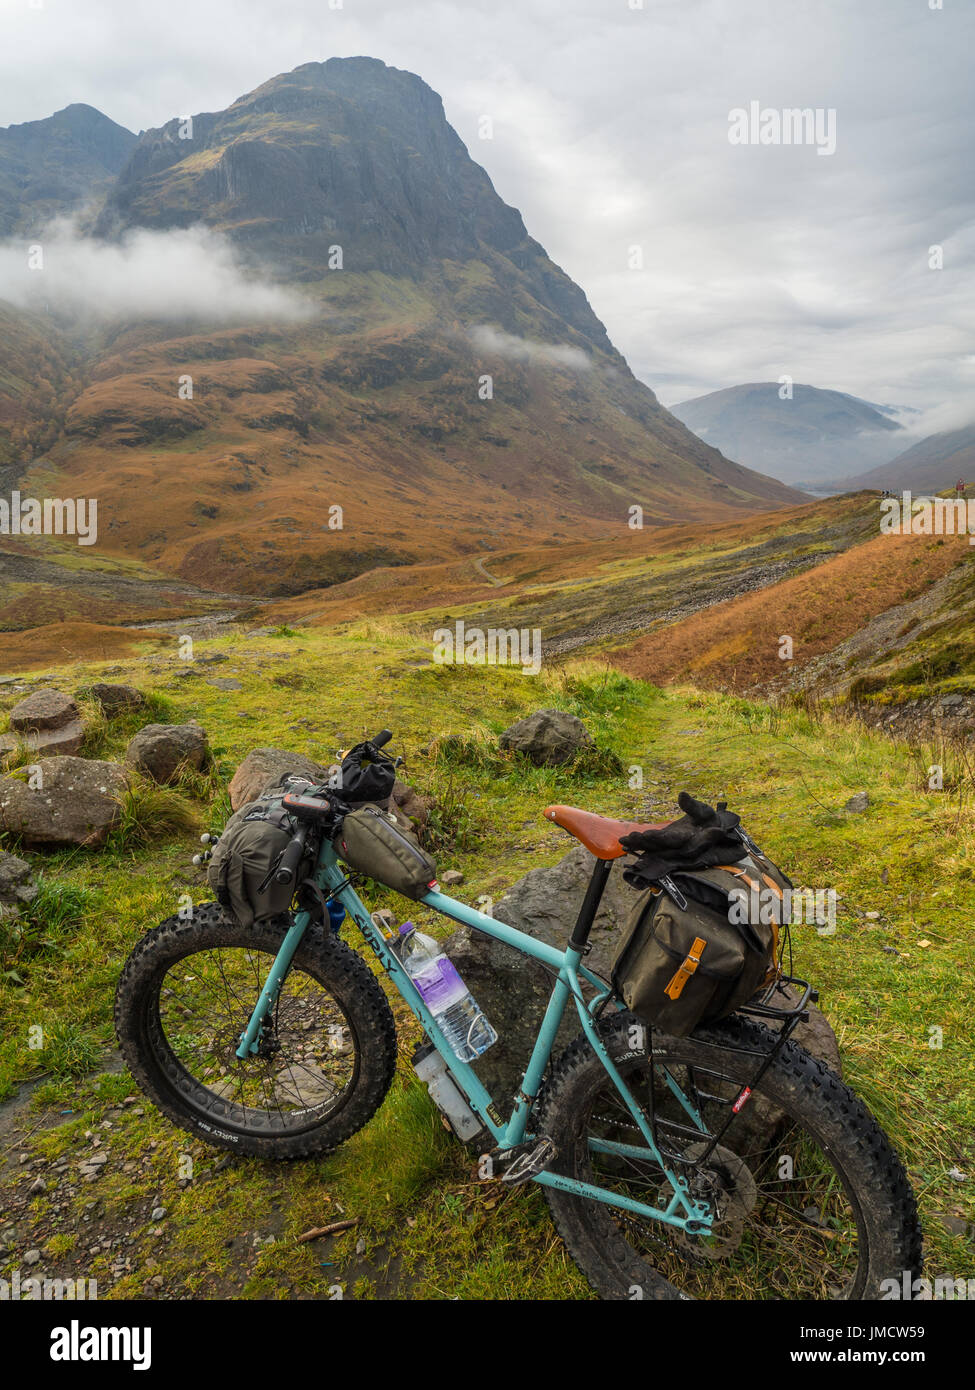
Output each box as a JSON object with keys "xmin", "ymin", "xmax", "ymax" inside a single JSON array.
[{"xmin": 115, "ymin": 902, "xmax": 396, "ymax": 1158}]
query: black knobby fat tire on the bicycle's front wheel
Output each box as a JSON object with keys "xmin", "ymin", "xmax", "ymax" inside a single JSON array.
[{"xmin": 115, "ymin": 902, "xmax": 396, "ymax": 1159}]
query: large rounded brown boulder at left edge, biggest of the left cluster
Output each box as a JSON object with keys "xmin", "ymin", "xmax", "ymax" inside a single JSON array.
[{"xmin": 0, "ymin": 758, "xmax": 127, "ymax": 848}]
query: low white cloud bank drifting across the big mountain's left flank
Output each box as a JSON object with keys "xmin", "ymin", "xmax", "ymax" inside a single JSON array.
[{"xmin": 0, "ymin": 220, "xmax": 316, "ymax": 322}]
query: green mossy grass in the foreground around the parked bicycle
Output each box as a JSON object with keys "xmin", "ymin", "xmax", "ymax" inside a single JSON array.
[{"xmin": 0, "ymin": 624, "xmax": 975, "ymax": 1298}]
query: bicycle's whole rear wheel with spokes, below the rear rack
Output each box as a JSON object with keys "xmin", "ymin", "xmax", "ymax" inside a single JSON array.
[{"xmin": 541, "ymin": 1013, "xmax": 921, "ymax": 1300}]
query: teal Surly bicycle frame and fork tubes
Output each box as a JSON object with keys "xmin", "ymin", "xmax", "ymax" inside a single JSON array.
[{"xmin": 236, "ymin": 840, "xmax": 712, "ymax": 1234}]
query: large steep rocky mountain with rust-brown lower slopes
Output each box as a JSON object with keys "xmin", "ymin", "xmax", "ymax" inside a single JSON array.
[{"xmin": 1, "ymin": 58, "xmax": 801, "ymax": 616}]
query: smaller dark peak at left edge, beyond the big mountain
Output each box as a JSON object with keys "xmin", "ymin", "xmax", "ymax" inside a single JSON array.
[{"xmin": 0, "ymin": 103, "xmax": 138, "ymax": 236}]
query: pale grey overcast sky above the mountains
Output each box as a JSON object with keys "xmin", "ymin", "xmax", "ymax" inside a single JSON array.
[{"xmin": 0, "ymin": 0, "xmax": 975, "ymax": 427}]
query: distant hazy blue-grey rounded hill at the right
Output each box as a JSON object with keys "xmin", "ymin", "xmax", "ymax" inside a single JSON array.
[{"xmin": 670, "ymin": 381, "xmax": 901, "ymax": 485}]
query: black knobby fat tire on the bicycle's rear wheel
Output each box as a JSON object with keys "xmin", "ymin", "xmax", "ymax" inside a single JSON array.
[{"xmin": 538, "ymin": 1013, "xmax": 921, "ymax": 1300}]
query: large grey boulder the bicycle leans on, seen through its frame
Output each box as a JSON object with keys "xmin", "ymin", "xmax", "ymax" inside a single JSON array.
[{"xmin": 445, "ymin": 845, "xmax": 840, "ymax": 1126}]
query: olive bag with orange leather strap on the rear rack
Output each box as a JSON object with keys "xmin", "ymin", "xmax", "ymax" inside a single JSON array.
[{"xmin": 612, "ymin": 852, "xmax": 791, "ymax": 1037}]
